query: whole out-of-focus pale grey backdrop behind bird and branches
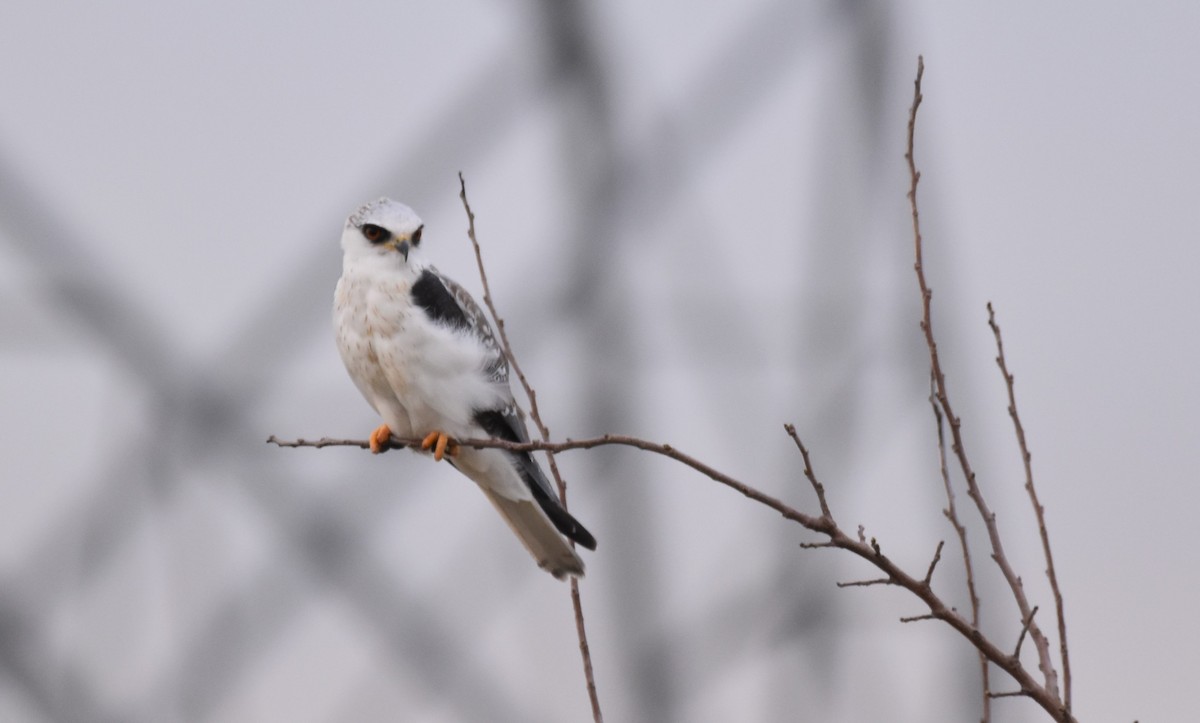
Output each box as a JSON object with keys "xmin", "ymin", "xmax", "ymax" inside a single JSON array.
[{"xmin": 0, "ymin": 0, "xmax": 1200, "ymax": 722}]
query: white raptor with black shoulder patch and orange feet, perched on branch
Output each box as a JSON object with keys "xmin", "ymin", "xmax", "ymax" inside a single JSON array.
[{"xmin": 334, "ymin": 198, "xmax": 596, "ymax": 579}]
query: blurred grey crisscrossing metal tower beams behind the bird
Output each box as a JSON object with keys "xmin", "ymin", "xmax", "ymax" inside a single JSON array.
[{"xmin": 0, "ymin": 0, "xmax": 955, "ymax": 722}]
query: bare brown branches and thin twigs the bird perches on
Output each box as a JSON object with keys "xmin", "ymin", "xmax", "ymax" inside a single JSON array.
[{"xmin": 268, "ymin": 59, "xmax": 1075, "ymax": 723}]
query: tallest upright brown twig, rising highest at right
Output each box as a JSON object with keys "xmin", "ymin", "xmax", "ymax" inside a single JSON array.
[{"xmin": 905, "ymin": 58, "xmax": 1069, "ymax": 719}]
